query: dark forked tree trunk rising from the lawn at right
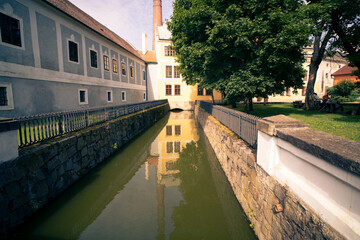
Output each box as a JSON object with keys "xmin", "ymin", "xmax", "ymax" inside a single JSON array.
[{"xmin": 305, "ymin": 28, "xmax": 333, "ymax": 110}]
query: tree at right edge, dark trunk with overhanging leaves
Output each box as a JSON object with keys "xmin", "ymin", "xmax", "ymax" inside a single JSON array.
[{"xmin": 305, "ymin": 0, "xmax": 360, "ymax": 110}]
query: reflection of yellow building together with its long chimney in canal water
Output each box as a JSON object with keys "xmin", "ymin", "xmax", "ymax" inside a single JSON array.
[{"xmin": 145, "ymin": 111, "xmax": 199, "ymax": 239}]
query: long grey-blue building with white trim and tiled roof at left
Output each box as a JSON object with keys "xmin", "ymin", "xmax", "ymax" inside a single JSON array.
[{"xmin": 0, "ymin": 0, "xmax": 147, "ymax": 117}]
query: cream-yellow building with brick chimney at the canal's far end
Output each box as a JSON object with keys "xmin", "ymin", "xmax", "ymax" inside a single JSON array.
[{"xmin": 143, "ymin": 0, "xmax": 221, "ymax": 110}]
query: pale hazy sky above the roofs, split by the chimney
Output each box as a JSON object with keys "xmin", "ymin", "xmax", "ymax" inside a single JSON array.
[{"xmin": 70, "ymin": 0, "xmax": 173, "ymax": 50}]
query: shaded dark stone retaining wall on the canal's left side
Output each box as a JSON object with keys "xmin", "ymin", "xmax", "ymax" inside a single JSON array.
[{"xmin": 0, "ymin": 104, "xmax": 169, "ymax": 235}]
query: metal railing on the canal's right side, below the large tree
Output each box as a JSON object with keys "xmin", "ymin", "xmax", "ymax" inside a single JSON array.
[{"xmin": 199, "ymin": 101, "xmax": 260, "ymax": 148}]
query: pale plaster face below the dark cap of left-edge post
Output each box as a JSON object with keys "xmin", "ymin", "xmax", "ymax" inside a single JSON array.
[{"xmin": 0, "ymin": 130, "xmax": 19, "ymax": 162}]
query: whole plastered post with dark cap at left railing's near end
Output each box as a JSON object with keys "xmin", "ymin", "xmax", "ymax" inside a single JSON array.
[{"xmin": 0, "ymin": 118, "xmax": 19, "ymax": 162}]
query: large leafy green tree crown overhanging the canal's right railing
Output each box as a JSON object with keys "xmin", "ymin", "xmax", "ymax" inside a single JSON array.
[{"xmin": 168, "ymin": 0, "xmax": 309, "ymax": 110}]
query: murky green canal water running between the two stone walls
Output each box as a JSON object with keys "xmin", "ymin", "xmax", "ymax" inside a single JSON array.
[{"xmin": 16, "ymin": 111, "xmax": 256, "ymax": 240}]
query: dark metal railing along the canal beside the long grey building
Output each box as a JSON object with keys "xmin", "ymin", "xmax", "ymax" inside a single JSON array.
[{"xmin": 16, "ymin": 100, "xmax": 167, "ymax": 147}]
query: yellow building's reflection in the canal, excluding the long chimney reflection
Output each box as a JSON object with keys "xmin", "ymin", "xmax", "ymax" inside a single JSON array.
[{"xmin": 146, "ymin": 111, "xmax": 199, "ymax": 187}]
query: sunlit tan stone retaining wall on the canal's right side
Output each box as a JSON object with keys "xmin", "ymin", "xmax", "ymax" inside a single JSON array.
[{"xmin": 195, "ymin": 106, "xmax": 344, "ymax": 239}]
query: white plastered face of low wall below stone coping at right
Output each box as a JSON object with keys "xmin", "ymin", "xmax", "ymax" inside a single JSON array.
[{"xmin": 257, "ymin": 131, "xmax": 360, "ymax": 239}]
